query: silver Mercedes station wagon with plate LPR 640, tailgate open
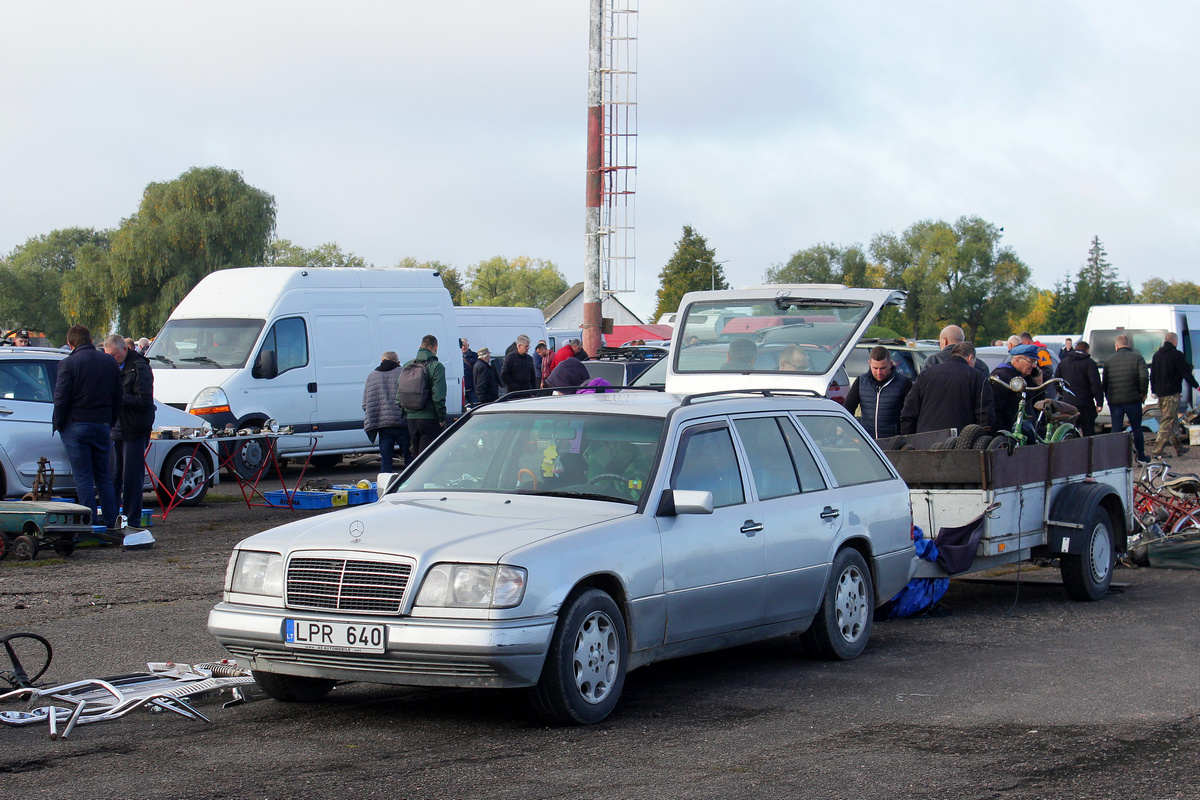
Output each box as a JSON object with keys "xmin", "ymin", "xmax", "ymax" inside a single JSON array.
[{"xmin": 209, "ymin": 285, "xmax": 914, "ymax": 723}]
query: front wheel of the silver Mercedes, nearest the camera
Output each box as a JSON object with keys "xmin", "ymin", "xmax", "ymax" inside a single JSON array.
[{"xmin": 533, "ymin": 589, "xmax": 629, "ymax": 724}]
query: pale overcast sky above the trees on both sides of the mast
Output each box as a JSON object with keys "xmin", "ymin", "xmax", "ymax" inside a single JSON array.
[{"xmin": 0, "ymin": 0, "xmax": 1200, "ymax": 315}]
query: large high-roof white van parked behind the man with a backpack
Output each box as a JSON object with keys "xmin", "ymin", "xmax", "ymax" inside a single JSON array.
[{"xmin": 146, "ymin": 266, "xmax": 462, "ymax": 475}]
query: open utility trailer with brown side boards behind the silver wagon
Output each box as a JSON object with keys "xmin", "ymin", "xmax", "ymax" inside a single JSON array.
[{"xmin": 886, "ymin": 432, "xmax": 1133, "ymax": 600}]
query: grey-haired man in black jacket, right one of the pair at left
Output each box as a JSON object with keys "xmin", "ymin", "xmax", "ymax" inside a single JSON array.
[{"xmin": 104, "ymin": 333, "xmax": 154, "ymax": 525}]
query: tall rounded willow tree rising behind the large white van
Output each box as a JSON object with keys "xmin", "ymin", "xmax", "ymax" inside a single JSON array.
[{"xmin": 64, "ymin": 167, "xmax": 275, "ymax": 336}]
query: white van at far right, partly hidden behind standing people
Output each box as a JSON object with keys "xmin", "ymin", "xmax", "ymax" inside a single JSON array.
[{"xmin": 1082, "ymin": 303, "xmax": 1200, "ymax": 425}]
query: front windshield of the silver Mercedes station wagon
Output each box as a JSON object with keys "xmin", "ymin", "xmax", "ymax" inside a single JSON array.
[{"xmin": 397, "ymin": 410, "xmax": 664, "ymax": 504}]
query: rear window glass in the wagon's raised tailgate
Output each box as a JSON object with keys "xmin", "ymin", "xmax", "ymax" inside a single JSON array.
[{"xmin": 673, "ymin": 299, "xmax": 870, "ymax": 375}]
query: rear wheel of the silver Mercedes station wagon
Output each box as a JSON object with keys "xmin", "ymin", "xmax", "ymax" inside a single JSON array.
[{"xmin": 803, "ymin": 547, "xmax": 875, "ymax": 661}]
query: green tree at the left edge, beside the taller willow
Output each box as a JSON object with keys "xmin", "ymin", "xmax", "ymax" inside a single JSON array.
[{"xmin": 0, "ymin": 228, "xmax": 110, "ymax": 342}]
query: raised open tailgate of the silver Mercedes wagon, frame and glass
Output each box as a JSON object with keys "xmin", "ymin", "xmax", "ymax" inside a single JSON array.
[{"xmin": 666, "ymin": 283, "xmax": 905, "ymax": 395}]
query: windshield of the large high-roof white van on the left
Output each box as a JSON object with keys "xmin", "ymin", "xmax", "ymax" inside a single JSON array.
[{"xmin": 146, "ymin": 319, "xmax": 266, "ymax": 369}]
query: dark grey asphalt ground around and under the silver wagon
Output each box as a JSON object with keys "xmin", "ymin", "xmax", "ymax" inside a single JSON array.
[{"xmin": 0, "ymin": 450, "xmax": 1200, "ymax": 800}]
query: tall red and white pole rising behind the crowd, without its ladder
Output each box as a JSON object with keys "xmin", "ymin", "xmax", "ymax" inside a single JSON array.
[{"xmin": 583, "ymin": 0, "xmax": 604, "ymax": 355}]
